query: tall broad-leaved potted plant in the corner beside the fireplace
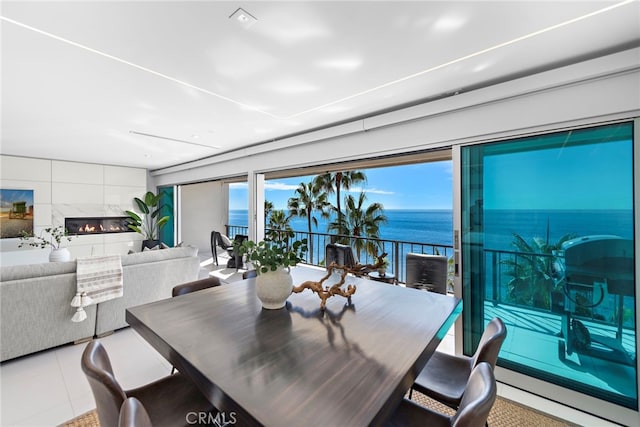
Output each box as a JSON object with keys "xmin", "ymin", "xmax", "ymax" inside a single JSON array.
[{"xmin": 125, "ymin": 191, "xmax": 169, "ymax": 250}]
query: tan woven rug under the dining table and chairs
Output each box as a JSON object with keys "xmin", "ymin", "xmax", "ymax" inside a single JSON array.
[{"xmin": 62, "ymin": 392, "xmax": 575, "ymax": 427}]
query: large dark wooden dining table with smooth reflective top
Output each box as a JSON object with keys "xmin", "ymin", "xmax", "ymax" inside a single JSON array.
[{"xmin": 126, "ymin": 266, "xmax": 462, "ymax": 426}]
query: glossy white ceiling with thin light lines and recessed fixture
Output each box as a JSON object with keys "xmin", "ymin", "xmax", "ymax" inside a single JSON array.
[{"xmin": 0, "ymin": 1, "xmax": 640, "ymax": 169}]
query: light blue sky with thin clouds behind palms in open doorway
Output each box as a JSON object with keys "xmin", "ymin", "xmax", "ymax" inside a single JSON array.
[{"xmin": 229, "ymin": 161, "xmax": 453, "ymax": 209}]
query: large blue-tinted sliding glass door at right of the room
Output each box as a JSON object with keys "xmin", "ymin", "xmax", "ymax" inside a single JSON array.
[{"xmin": 461, "ymin": 122, "xmax": 638, "ymax": 409}]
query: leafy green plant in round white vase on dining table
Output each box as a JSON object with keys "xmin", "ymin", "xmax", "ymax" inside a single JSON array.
[{"xmin": 234, "ymin": 231, "xmax": 307, "ymax": 310}]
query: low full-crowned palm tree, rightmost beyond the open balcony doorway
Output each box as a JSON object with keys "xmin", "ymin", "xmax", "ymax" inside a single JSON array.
[{"xmin": 329, "ymin": 192, "xmax": 387, "ymax": 258}]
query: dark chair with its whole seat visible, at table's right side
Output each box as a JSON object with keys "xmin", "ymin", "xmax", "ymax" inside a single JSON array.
[{"xmin": 409, "ymin": 317, "xmax": 507, "ymax": 408}]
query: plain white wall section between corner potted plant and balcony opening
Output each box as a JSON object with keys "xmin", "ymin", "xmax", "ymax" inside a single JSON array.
[{"xmin": 179, "ymin": 181, "xmax": 229, "ymax": 252}]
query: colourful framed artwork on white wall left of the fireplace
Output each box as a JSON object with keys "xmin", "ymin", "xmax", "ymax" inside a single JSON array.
[{"xmin": 0, "ymin": 188, "xmax": 33, "ymax": 239}]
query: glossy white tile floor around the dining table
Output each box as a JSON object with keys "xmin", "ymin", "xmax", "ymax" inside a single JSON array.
[{"xmin": 0, "ymin": 257, "xmax": 624, "ymax": 427}]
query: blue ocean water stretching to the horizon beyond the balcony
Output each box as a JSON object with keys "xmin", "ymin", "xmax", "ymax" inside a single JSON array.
[{"xmin": 229, "ymin": 209, "xmax": 633, "ymax": 251}]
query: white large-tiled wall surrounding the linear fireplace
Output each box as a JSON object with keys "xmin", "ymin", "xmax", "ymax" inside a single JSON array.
[{"xmin": 0, "ymin": 155, "xmax": 147, "ymax": 265}]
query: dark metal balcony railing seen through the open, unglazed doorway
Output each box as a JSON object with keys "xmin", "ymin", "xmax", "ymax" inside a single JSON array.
[{"xmin": 226, "ymin": 225, "xmax": 453, "ymax": 289}]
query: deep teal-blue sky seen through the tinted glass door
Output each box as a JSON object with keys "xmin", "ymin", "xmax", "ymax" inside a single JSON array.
[{"xmin": 484, "ymin": 140, "xmax": 633, "ymax": 209}]
